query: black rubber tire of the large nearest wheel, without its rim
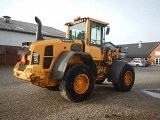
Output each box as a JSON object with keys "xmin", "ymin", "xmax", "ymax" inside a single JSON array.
[{"xmin": 59, "ymin": 64, "xmax": 94, "ymax": 102}]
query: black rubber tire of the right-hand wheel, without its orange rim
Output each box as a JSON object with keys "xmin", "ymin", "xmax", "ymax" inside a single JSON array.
[{"xmin": 112, "ymin": 64, "xmax": 135, "ymax": 92}]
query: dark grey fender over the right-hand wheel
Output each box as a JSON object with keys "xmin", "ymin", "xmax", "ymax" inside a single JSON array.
[{"xmin": 107, "ymin": 60, "xmax": 128, "ymax": 83}]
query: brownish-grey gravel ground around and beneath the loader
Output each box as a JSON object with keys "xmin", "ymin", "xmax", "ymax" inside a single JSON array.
[{"xmin": 0, "ymin": 66, "xmax": 160, "ymax": 120}]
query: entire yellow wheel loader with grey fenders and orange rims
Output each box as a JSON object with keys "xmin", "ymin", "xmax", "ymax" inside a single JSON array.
[{"xmin": 13, "ymin": 17, "xmax": 135, "ymax": 102}]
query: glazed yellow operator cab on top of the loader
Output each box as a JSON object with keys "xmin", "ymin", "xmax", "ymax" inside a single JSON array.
[{"xmin": 65, "ymin": 17, "xmax": 110, "ymax": 50}]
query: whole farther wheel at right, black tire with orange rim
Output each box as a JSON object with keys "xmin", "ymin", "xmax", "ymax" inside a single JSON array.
[{"xmin": 112, "ymin": 64, "xmax": 135, "ymax": 92}]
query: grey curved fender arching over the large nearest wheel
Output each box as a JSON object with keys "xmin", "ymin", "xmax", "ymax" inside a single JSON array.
[{"xmin": 50, "ymin": 51, "xmax": 97, "ymax": 80}]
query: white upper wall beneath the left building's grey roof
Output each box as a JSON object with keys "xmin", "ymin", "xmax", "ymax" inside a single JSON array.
[{"xmin": 0, "ymin": 30, "xmax": 51, "ymax": 46}]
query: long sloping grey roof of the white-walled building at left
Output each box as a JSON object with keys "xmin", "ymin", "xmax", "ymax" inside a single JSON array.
[{"xmin": 0, "ymin": 16, "xmax": 65, "ymax": 38}]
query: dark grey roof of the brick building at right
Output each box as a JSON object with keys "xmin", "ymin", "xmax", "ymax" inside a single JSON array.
[{"xmin": 119, "ymin": 41, "xmax": 160, "ymax": 58}]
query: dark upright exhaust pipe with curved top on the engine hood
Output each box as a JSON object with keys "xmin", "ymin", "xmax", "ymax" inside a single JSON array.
[{"xmin": 35, "ymin": 16, "xmax": 43, "ymax": 41}]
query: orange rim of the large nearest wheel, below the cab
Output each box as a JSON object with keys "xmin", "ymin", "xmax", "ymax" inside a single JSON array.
[{"xmin": 74, "ymin": 74, "xmax": 89, "ymax": 94}]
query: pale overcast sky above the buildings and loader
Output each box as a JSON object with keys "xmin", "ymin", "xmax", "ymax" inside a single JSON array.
[{"xmin": 0, "ymin": 0, "xmax": 160, "ymax": 44}]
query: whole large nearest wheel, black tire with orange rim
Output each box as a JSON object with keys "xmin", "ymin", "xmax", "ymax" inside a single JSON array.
[{"xmin": 59, "ymin": 64, "xmax": 94, "ymax": 102}]
